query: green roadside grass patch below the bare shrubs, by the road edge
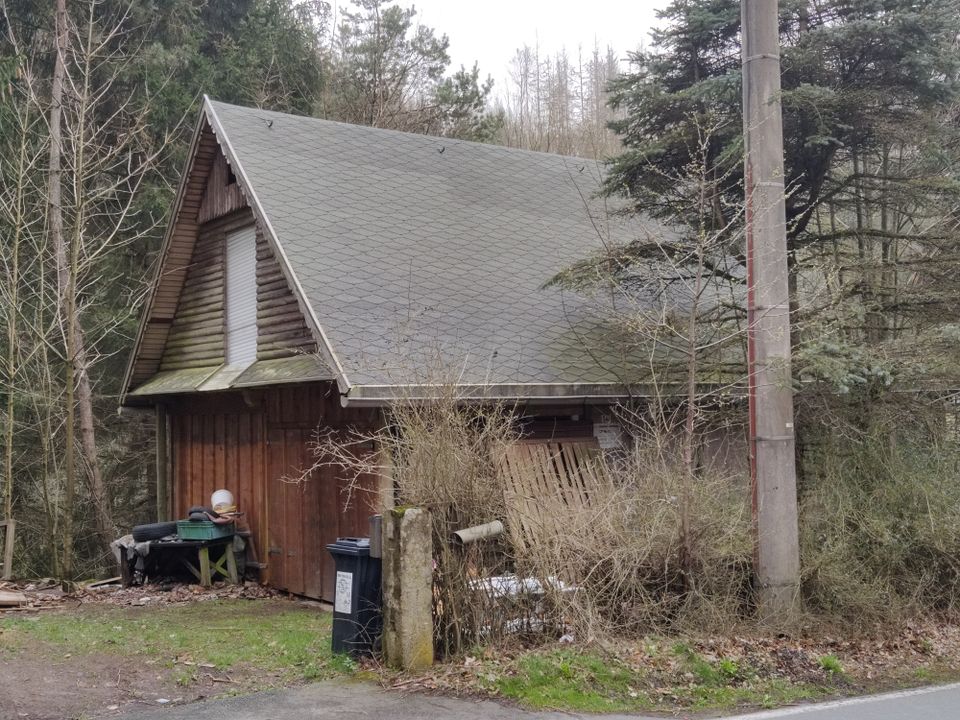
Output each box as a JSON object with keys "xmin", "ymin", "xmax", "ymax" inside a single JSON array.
[{"xmin": 492, "ymin": 643, "xmax": 831, "ymax": 712}]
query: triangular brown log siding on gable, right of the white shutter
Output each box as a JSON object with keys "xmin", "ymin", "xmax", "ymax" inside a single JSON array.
[{"xmin": 257, "ymin": 227, "xmax": 317, "ymax": 360}]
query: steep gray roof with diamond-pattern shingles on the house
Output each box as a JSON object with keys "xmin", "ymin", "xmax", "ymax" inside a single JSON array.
[{"xmin": 209, "ymin": 102, "xmax": 668, "ymax": 394}]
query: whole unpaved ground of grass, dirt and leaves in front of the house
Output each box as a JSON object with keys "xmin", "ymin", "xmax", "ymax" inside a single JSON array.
[{"xmin": 0, "ymin": 582, "xmax": 960, "ymax": 720}]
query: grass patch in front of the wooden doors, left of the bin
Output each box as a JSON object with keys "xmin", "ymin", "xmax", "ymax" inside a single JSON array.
[{"xmin": 0, "ymin": 600, "xmax": 344, "ymax": 686}]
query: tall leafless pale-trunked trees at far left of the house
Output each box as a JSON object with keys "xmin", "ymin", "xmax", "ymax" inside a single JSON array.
[{"xmin": 2, "ymin": 0, "xmax": 176, "ymax": 582}]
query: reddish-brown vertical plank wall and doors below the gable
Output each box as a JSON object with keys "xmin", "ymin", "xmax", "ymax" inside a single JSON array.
[{"xmin": 169, "ymin": 383, "xmax": 379, "ymax": 601}]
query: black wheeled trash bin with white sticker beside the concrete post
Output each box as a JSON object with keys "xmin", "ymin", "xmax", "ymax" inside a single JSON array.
[{"xmin": 327, "ymin": 538, "xmax": 383, "ymax": 656}]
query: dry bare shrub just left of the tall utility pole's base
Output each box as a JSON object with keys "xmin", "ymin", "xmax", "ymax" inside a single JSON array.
[{"xmin": 517, "ymin": 408, "xmax": 752, "ymax": 640}]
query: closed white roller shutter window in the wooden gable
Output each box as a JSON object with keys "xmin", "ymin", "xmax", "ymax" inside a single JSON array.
[{"xmin": 226, "ymin": 227, "xmax": 257, "ymax": 366}]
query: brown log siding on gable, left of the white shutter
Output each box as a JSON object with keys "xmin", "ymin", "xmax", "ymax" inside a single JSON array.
[{"xmin": 160, "ymin": 209, "xmax": 253, "ymax": 371}]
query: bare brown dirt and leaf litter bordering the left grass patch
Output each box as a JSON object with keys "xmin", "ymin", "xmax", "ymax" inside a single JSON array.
[{"xmin": 0, "ymin": 583, "xmax": 330, "ymax": 720}]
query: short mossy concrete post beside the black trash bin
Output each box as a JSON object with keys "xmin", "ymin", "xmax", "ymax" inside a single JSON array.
[{"xmin": 383, "ymin": 507, "xmax": 433, "ymax": 670}]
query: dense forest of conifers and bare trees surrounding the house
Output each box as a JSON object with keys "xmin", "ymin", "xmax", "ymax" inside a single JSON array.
[{"xmin": 0, "ymin": 0, "xmax": 960, "ymax": 620}]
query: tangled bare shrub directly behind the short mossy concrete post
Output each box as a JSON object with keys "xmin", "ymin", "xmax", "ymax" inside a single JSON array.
[{"xmin": 314, "ymin": 389, "xmax": 517, "ymax": 655}]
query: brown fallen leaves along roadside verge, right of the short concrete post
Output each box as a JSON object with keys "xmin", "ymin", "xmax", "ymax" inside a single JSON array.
[{"xmin": 381, "ymin": 617, "xmax": 960, "ymax": 705}]
